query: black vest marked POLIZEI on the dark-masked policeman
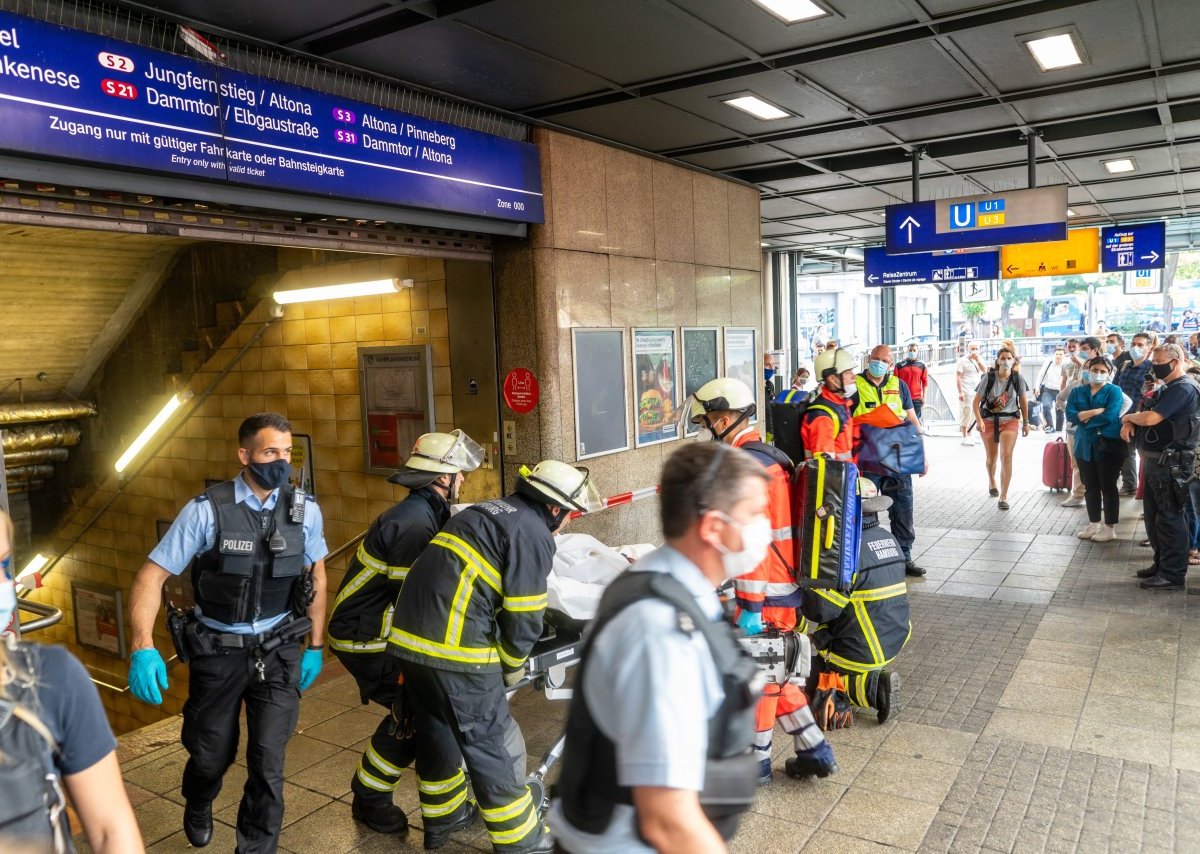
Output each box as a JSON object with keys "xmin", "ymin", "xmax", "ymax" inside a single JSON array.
[{"xmin": 192, "ymin": 481, "xmax": 307, "ymax": 625}]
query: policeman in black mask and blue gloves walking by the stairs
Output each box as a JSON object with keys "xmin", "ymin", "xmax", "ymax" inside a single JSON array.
[{"xmin": 130, "ymin": 413, "xmax": 326, "ymax": 854}]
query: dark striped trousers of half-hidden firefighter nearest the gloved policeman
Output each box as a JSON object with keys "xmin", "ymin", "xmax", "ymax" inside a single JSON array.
[{"xmin": 334, "ymin": 650, "xmax": 416, "ymax": 805}]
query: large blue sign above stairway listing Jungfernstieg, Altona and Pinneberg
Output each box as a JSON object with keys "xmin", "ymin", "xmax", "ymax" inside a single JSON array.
[{"xmin": 0, "ymin": 12, "xmax": 544, "ymax": 222}]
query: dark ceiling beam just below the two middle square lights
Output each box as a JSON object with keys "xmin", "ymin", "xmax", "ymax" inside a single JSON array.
[{"xmin": 655, "ymin": 60, "xmax": 1200, "ymax": 157}]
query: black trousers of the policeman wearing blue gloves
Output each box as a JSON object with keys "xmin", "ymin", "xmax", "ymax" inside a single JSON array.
[{"xmin": 182, "ymin": 643, "xmax": 301, "ymax": 854}]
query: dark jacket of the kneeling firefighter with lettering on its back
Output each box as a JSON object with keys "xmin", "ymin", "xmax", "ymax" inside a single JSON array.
[{"xmin": 800, "ymin": 517, "xmax": 912, "ymax": 673}]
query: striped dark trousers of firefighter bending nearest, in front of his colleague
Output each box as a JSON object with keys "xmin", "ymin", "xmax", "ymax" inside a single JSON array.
[{"xmin": 403, "ymin": 661, "xmax": 541, "ymax": 852}]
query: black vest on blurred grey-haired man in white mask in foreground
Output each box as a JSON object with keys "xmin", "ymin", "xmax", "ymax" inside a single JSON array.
[{"xmin": 556, "ymin": 572, "xmax": 762, "ymax": 840}]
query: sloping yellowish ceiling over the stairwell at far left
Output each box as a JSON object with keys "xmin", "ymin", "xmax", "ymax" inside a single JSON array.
[{"xmin": 0, "ymin": 225, "xmax": 185, "ymax": 402}]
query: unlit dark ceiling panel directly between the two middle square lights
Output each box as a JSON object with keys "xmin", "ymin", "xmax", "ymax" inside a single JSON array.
[{"xmin": 804, "ymin": 42, "xmax": 980, "ymax": 113}]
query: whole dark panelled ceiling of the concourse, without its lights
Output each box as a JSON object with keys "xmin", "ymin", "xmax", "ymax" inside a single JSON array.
[{"xmin": 116, "ymin": 0, "xmax": 1200, "ymax": 261}]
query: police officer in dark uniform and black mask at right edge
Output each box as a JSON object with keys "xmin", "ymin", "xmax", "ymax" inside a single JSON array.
[{"xmin": 1121, "ymin": 344, "xmax": 1200, "ymax": 590}]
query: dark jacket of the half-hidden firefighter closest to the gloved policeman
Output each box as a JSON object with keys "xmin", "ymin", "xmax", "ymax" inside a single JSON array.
[{"xmin": 328, "ymin": 487, "xmax": 450, "ymax": 652}]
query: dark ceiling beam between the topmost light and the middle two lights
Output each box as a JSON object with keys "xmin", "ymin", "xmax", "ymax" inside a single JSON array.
[{"xmin": 521, "ymin": 0, "xmax": 1098, "ymax": 119}]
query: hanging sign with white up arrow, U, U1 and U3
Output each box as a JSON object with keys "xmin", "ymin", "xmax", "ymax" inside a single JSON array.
[{"xmin": 884, "ymin": 185, "xmax": 1067, "ymax": 255}]
